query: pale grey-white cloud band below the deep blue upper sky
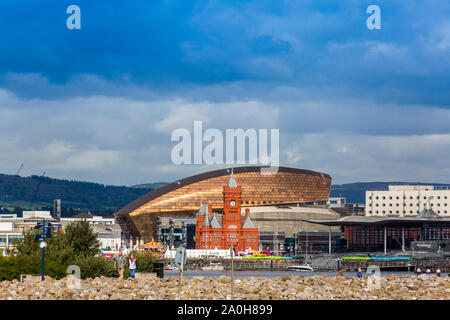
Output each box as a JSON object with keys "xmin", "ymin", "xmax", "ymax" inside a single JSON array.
[{"xmin": 0, "ymin": 78, "xmax": 450, "ymax": 185}]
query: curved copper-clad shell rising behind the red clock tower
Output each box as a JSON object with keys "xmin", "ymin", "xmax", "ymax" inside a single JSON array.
[{"xmin": 116, "ymin": 166, "xmax": 331, "ymax": 241}]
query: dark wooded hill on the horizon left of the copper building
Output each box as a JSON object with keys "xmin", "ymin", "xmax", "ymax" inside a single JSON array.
[{"xmin": 0, "ymin": 174, "xmax": 152, "ymax": 212}]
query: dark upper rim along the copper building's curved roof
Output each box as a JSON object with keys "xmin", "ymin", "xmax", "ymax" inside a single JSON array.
[{"xmin": 115, "ymin": 166, "xmax": 331, "ymax": 217}]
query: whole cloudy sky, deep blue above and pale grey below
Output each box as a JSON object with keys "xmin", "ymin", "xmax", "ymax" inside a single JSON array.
[{"xmin": 0, "ymin": 0, "xmax": 450, "ymax": 185}]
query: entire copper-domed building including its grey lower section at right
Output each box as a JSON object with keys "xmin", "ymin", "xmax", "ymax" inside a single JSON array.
[{"xmin": 115, "ymin": 166, "xmax": 339, "ymax": 246}]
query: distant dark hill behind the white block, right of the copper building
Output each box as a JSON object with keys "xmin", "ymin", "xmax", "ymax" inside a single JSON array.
[{"xmin": 330, "ymin": 181, "xmax": 449, "ymax": 203}]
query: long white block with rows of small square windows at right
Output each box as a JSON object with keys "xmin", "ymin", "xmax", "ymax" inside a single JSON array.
[{"xmin": 365, "ymin": 185, "xmax": 450, "ymax": 217}]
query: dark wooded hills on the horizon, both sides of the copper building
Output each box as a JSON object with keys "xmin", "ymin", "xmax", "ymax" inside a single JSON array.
[{"xmin": 0, "ymin": 174, "xmax": 448, "ymax": 216}]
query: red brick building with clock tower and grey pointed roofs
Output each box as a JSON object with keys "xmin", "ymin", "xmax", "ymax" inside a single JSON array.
[{"xmin": 195, "ymin": 172, "xmax": 258, "ymax": 253}]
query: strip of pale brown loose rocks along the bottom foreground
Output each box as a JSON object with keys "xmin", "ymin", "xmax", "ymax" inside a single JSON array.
[{"xmin": 0, "ymin": 275, "xmax": 450, "ymax": 300}]
